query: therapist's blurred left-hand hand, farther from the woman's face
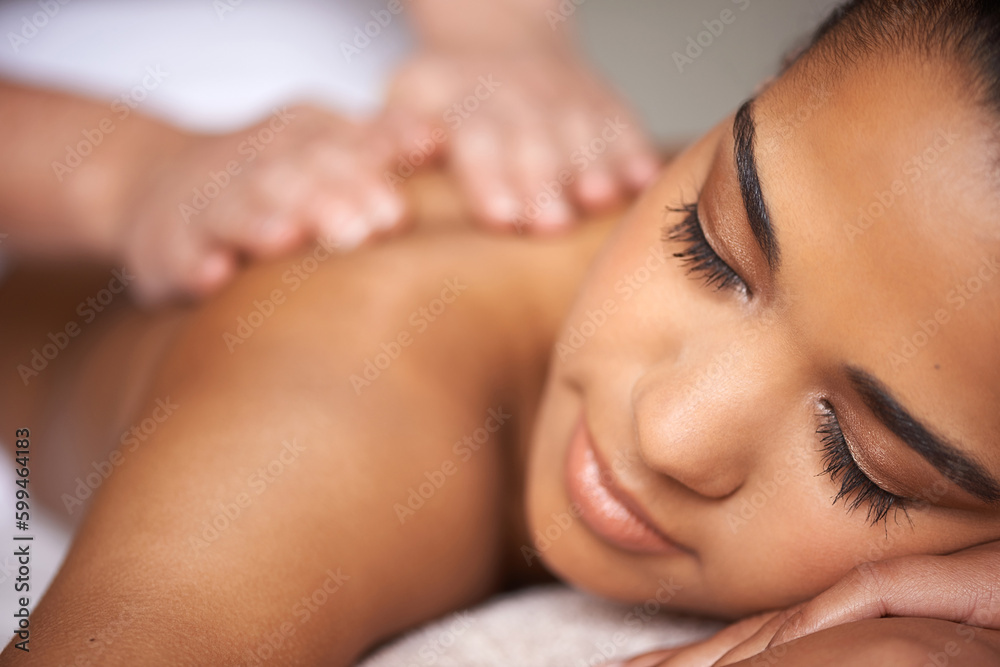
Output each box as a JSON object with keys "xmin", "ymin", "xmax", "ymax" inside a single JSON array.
[{"xmin": 117, "ymin": 106, "xmax": 404, "ymax": 302}]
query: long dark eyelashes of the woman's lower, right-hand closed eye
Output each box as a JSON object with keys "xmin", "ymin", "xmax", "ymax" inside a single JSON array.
[{"xmin": 816, "ymin": 401, "xmax": 909, "ymax": 526}]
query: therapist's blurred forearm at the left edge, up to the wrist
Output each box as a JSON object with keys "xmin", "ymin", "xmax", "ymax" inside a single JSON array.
[{"xmin": 0, "ymin": 81, "xmax": 183, "ymax": 260}]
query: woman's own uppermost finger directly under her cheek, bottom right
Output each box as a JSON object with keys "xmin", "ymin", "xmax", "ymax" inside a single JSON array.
[{"xmin": 771, "ymin": 551, "xmax": 1000, "ymax": 645}]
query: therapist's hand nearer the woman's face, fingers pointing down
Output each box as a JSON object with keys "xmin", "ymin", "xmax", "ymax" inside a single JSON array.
[{"xmin": 387, "ymin": 47, "xmax": 658, "ymax": 232}]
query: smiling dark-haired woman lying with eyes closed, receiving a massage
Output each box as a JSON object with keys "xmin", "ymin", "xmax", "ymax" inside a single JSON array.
[{"xmin": 0, "ymin": 0, "xmax": 1000, "ymax": 665}]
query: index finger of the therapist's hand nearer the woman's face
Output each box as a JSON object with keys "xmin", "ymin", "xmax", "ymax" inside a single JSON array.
[{"xmin": 451, "ymin": 117, "xmax": 521, "ymax": 229}]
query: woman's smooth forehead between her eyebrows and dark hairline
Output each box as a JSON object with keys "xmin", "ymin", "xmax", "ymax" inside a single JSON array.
[{"xmin": 754, "ymin": 58, "xmax": 1000, "ymax": 465}]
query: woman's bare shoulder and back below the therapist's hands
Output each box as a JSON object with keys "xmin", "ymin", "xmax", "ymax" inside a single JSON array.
[{"xmin": 0, "ymin": 174, "xmax": 606, "ymax": 664}]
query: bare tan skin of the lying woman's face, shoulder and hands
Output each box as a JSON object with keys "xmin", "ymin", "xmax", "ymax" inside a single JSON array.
[{"xmin": 2, "ymin": 35, "xmax": 1000, "ymax": 666}]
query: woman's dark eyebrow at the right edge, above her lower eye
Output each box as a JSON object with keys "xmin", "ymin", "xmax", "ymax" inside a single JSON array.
[{"xmin": 847, "ymin": 367, "xmax": 1000, "ymax": 504}]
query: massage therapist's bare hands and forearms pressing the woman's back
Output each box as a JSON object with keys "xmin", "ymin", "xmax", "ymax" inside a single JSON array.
[{"xmin": 0, "ymin": 0, "xmax": 658, "ymax": 303}]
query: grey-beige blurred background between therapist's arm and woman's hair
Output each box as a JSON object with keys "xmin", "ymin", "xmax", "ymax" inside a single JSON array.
[{"xmin": 574, "ymin": 0, "xmax": 840, "ymax": 145}]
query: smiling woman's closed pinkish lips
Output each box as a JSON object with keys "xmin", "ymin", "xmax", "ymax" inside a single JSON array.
[{"xmin": 566, "ymin": 416, "xmax": 689, "ymax": 555}]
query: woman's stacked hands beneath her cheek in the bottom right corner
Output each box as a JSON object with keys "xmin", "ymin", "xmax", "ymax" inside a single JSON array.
[{"xmin": 604, "ymin": 542, "xmax": 1000, "ymax": 667}]
